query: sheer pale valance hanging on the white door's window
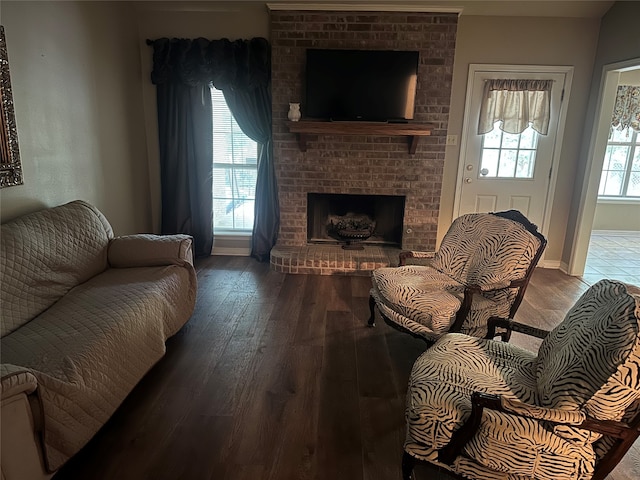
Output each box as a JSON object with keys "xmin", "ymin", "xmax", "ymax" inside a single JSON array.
[{"xmin": 478, "ymin": 79, "xmax": 553, "ymax": 135}]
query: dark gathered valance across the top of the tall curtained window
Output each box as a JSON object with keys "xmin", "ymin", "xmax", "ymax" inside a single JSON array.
[{"xmin": 147, "ymin": 37, "xmax": 271, "ymax": 90}]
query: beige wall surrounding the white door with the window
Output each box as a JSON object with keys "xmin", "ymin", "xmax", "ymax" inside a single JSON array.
[{"xmin": 438, "ymin": 14, "xmax": 599, "ymax": 265}]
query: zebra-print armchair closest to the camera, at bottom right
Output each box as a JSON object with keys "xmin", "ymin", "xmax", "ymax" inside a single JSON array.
[{"xmin": 402, "ymin": 280, "xmax": 640, "ymax": 480}]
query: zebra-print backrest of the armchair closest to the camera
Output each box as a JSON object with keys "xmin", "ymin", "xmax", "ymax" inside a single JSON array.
[{"xmin": 536, "ymin": 280, "xmax": 640, "ymax": 420}]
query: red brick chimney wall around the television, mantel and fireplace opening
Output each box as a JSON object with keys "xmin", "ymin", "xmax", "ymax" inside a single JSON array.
[{"xmin": 271, "ymin": 11, "xmax": 458, "ymax": 250}]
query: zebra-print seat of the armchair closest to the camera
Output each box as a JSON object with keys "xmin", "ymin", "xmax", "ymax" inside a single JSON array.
[{"xmin": 405, "ymin": 333, "xmax": 536, "ymax": 461}]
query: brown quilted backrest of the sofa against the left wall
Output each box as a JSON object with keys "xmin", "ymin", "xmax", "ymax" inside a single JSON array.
[{"xmin": 0, "ymin": 201, "xmax": 113, "ymax": 337}]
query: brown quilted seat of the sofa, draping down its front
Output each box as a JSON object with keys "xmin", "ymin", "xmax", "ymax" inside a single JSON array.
[{"xmin": 1, "ymin": 265, "xmax": 196, "ymax": 471}]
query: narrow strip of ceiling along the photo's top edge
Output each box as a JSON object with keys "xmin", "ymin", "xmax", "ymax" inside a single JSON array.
[{"xmin": 136, "ymin": 0, "xmax": 615, "ymax": 18}]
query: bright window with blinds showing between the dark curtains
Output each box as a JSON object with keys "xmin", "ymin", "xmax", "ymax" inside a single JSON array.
[{"xmin": 211, "ymin": 87, "xmax": 258, "ymax": 233}]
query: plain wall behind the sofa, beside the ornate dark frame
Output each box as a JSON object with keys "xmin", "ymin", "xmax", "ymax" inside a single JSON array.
[{"xmin": 0, "ymin": 0, "xmax": 151, "ymax": 234}]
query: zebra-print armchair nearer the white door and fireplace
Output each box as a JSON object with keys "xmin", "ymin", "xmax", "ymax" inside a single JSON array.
[{"xmin": 369, "ymin": 210, "xmax": 547, "ymax": 342}]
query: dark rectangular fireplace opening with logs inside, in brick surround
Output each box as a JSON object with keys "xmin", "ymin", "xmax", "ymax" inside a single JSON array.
[{"xmin": 307, "ymin": 193, "xmax": 405, "ymax": 248}]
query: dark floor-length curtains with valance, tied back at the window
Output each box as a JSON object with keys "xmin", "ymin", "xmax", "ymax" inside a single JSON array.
[{"xmin": 148, "ymin": 38, "xmax": 280, "ymax": 261}]
